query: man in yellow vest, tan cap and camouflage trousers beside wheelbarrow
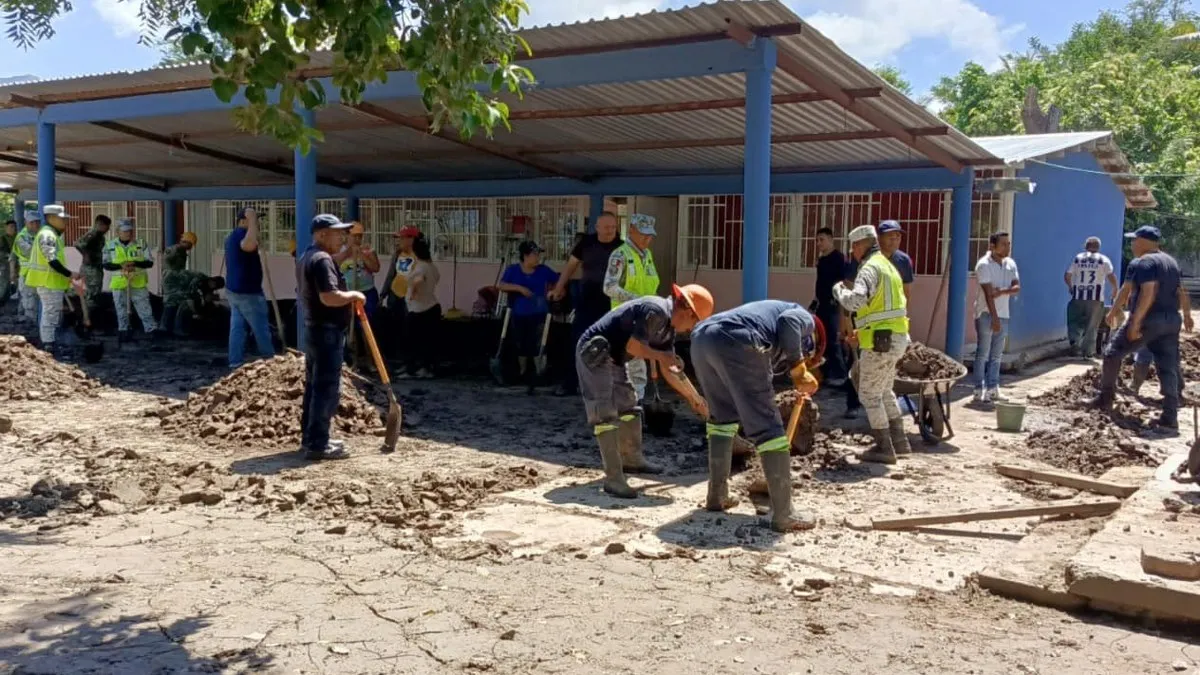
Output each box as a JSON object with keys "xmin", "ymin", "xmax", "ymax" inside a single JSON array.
[{"xmin": 833, "ymin": 225, "xmax": 912, "ymax": 464}]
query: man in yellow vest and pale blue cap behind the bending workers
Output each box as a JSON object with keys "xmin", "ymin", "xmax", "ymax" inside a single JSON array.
[{"xmin": 604, "ymin": 214, "xmax": 659, "ymax": 401}]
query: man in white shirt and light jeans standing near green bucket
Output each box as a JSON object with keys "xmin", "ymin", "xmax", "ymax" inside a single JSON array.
[{"xmin": 973, "ymin": 232, "xmax": 1021, "ymax": 402}]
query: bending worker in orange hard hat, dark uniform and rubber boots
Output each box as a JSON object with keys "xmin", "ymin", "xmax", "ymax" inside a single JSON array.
[{"xmin": 575, "ymin": 283, "xmax": 713, "ymax": 500}]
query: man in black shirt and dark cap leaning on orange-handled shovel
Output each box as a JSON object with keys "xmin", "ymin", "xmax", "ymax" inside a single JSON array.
[{"xmin": 296, "ymin": 214, "xmax": 366, "ymax": 460}]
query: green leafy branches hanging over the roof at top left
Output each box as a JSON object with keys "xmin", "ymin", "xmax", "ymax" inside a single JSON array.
[{"xmin": 0, "ymin": 0, "xmax": 533, "ymax": 150}]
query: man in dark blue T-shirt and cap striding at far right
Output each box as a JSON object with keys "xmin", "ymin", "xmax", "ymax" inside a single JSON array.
[{"xmin": 1090, "ymin": 225, "xmax": 1192, "ymax": 431}]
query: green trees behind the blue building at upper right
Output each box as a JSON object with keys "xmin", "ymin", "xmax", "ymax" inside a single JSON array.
[{"xmin": 934, "ymin": 0, "xmax": 1200, "ymax": 253}]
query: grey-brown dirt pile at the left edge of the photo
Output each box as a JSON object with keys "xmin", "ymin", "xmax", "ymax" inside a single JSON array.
[{"xmin": 0, "ymin": 335, "xmax": 102, "ymax": 401}]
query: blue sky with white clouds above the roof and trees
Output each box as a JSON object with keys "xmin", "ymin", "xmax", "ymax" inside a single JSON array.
[{"xmin": 0, "ymin": 0, "xmax": 1126, "ymax": 95}]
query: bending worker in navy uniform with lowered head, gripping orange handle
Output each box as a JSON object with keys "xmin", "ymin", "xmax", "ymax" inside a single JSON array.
[{"xmin": 691, "ymin": 300, "xmax": 823, "ymax": 532}]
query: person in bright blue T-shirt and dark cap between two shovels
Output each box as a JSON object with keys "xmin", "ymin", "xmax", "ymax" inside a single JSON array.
[{"xmin": 496, "ymin": 240, "xmax": 558, "ymax": 394}]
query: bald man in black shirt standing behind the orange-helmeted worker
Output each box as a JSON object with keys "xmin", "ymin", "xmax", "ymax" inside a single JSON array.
[{"xmin": 548, "ymin": 211, "xmax": 622, "ymax": 395}]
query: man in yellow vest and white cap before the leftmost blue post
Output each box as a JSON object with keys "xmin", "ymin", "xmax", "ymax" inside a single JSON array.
[{"xmin": 25, "ymin": 204, "xmax": 82, "ymax": 358}]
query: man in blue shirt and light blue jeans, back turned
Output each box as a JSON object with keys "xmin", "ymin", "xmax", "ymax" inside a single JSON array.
[{"xmin": 224, "ymin": 207, "xmax": 274, "ymax": 368}]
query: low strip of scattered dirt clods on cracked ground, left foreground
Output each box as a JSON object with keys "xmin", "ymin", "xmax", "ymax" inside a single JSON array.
[{"xmin": 0, "ymin": 438, "xmax": 539, "ymax": 530}]
